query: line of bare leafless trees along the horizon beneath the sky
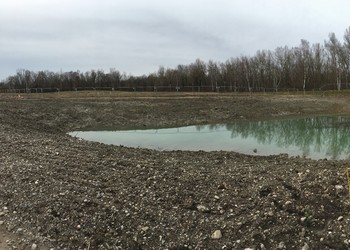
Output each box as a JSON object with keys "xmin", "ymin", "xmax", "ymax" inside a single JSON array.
[{"xmin": 0, "ymin": 27, "xmax": 350, "ymax": 92}]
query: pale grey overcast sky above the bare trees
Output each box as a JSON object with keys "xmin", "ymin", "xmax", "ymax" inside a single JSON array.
[{"xmin": 0, "ymin": 0, "xmax": 350, "ymax": 80}]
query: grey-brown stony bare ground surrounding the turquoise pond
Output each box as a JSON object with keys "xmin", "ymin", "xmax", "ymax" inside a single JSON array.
[{"xmin": 0, "ymin": 93, "xmax": 350, "ymax": 250}]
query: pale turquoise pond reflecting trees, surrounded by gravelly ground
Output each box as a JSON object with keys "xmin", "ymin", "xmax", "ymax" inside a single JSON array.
[{"xmin": 69, "ymin": 116, "xmax": 350, "ymax": 159}]
